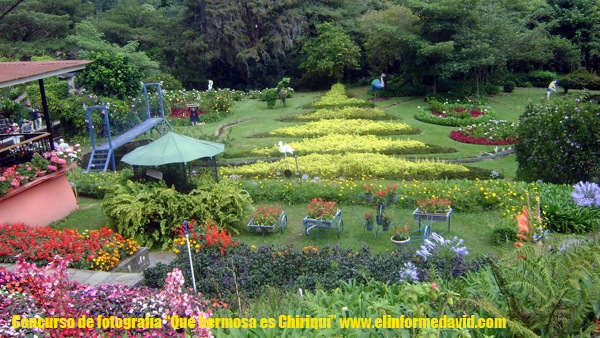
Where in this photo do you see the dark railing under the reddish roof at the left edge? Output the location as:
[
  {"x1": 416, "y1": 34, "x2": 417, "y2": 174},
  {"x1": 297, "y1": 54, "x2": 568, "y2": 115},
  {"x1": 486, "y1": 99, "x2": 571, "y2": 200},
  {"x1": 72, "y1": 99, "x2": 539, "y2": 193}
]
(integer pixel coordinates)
[{"x1": 0, "y1": 133, "x2": 52, "y2": 171}]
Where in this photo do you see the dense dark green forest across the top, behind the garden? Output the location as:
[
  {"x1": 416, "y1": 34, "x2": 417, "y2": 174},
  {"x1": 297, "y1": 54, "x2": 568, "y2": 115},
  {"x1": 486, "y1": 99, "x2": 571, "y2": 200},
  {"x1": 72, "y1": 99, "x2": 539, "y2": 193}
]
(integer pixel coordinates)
[{"x1": 0, "y1": 0, "x2": 600, "y2": 91}]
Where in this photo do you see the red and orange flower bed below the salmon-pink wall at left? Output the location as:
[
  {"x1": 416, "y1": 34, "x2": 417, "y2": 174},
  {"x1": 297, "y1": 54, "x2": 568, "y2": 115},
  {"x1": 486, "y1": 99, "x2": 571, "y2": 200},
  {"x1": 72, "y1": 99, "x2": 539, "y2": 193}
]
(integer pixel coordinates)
[{"x1": 0, "y1": 224, "x2": 139, "y2": 270}]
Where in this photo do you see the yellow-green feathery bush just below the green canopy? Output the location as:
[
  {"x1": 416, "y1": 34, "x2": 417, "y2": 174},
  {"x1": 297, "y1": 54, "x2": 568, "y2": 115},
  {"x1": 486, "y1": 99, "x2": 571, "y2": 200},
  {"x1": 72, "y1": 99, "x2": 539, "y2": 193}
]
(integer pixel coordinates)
[{"x1": 102, "y1": 180, "x2": 252, "y2": 249}]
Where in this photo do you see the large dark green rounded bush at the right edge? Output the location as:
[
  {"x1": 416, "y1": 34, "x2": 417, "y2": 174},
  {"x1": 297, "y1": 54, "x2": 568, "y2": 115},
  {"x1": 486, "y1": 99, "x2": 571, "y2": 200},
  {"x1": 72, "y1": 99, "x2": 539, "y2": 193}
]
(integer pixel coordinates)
[{"x1": 515, "y1": 97, "x2": 600, "y2": 184}]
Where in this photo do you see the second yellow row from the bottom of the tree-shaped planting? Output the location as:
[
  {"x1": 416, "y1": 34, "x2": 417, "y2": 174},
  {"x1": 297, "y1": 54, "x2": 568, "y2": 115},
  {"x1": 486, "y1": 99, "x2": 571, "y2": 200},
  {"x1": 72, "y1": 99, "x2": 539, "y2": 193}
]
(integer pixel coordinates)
[{"x1": 252, "y1": 134, "x2": 428, "y2": 156}]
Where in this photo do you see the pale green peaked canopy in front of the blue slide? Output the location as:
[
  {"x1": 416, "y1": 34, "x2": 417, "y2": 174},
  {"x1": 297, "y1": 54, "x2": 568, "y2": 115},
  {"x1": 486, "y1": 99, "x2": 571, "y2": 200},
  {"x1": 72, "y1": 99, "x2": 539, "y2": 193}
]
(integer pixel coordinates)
[{"x1": 121, "y1": 133, "x2": 225, "y2": 166}]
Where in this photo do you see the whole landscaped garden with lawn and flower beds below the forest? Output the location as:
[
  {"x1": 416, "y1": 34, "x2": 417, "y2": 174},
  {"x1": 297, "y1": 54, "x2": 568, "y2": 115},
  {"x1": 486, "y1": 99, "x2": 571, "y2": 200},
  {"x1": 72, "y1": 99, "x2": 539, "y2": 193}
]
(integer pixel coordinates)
[{"x1": 0, "y1": 84, "x2": 600, "y2": 337}]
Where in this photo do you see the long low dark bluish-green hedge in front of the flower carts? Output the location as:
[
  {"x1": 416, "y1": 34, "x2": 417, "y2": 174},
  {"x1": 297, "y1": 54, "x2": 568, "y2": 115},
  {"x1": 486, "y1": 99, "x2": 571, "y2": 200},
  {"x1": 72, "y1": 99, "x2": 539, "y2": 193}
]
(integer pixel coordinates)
[{"x1": 144, "y1": 243, "x2": 481, "y2": 303}]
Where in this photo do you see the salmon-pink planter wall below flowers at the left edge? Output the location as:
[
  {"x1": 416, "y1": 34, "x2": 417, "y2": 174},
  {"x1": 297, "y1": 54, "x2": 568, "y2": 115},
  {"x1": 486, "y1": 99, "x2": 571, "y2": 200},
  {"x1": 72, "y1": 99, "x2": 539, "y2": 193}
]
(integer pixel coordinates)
[{"x1": 0, "y1": 168, "x2": 79, "y2": 227}]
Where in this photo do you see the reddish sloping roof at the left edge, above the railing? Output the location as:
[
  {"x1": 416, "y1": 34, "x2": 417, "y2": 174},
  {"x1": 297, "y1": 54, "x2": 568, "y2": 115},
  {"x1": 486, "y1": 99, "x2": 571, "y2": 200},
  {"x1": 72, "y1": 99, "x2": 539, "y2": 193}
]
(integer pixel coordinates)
[{"x1": 0, "y1": 60, "x2": 92, "y2": 88}]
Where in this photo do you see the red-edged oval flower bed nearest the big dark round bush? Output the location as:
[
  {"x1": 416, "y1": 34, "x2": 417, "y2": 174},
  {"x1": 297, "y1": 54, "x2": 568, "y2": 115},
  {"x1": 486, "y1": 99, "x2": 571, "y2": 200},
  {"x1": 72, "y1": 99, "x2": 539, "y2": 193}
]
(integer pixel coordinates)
[{"x1": 450, "y1": 120, "x2": 518, "y2": 146}]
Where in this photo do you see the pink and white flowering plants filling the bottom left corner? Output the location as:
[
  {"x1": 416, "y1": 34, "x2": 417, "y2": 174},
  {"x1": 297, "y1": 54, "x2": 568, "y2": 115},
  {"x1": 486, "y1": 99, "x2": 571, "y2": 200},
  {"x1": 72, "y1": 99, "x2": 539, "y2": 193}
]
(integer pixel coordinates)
[{"x1": 0, "y1": 256, "x2": 220, "y2": 338}]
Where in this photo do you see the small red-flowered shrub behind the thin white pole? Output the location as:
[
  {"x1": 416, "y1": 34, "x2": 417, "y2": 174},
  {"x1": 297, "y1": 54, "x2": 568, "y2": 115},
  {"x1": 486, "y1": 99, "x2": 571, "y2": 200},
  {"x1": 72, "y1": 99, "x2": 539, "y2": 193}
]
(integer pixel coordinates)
[{"x1": 173, "y1": 220, "x2": 238, "y2": 255}]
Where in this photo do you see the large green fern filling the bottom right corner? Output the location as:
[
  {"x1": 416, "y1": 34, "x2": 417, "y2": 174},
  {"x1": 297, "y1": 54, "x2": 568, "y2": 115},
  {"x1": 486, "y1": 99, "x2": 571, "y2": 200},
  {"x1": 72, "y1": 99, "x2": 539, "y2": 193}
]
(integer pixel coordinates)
[{"x1": 467, "y1": 243, "x2": 600, "y2": 337}]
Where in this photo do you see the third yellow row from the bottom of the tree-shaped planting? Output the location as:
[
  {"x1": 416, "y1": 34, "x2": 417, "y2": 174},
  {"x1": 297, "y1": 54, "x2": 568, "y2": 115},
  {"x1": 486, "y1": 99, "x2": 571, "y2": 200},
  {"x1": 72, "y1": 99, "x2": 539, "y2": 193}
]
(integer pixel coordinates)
[{"x1": 269, "y1": 119, "x2": 418, "y2": 137}]
